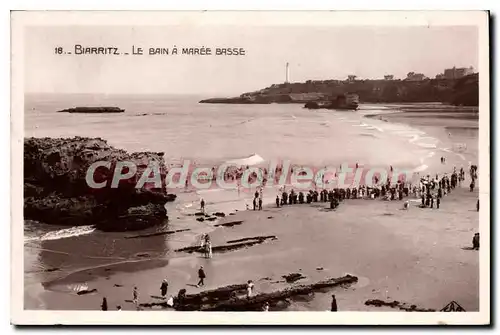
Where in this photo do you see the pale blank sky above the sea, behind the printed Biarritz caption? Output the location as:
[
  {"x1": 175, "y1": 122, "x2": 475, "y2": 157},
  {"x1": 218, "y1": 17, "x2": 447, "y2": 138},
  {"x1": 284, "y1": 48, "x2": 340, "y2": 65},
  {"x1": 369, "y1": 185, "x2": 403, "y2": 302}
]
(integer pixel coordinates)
[{"x1": 24, "y1": 25, "x2": 478, "y2": 96}]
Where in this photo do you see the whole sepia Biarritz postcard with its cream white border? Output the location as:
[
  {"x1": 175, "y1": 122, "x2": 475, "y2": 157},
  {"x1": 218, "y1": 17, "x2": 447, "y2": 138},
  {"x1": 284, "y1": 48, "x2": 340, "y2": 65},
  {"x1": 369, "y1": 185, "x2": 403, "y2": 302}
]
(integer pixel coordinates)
[{"x1": 11, "y1": 11, "x2": 490, "y2": 325}]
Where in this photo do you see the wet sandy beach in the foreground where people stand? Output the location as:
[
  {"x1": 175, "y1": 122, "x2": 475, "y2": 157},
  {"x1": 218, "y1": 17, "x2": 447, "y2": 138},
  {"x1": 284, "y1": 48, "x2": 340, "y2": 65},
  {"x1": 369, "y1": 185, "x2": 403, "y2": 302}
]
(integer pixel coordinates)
[{"x1": 25, "y1": 104, "x2": 479, "y2": 311}]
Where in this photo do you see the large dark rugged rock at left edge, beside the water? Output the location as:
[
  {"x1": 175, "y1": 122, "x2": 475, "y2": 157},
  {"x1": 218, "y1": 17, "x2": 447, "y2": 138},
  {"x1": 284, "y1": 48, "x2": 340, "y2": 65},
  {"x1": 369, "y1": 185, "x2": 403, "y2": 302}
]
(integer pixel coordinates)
[{"x1": 24, "y1": 137, "x2": 175, "y2": 231}]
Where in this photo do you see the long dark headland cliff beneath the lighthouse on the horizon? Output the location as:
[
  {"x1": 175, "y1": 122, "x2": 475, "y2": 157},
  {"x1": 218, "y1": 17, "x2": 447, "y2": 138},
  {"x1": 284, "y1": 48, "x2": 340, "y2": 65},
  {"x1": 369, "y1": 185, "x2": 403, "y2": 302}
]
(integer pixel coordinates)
[{"x1": 200, "y1": 73, "x2": 479, "y2": 106}]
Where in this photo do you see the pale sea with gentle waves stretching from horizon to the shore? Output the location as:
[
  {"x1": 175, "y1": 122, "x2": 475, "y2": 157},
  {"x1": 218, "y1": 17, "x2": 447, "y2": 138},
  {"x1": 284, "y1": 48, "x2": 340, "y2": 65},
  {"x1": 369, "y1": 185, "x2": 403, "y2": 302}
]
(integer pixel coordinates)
[{"x1": 24, "y1": 94, "x2": 468, "y2": 308}]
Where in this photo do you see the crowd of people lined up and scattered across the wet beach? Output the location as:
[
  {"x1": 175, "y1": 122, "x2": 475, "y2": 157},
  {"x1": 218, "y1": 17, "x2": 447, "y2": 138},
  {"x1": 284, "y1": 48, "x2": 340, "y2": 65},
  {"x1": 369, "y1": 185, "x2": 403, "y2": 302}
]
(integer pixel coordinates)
[{"x1": 96, "y1": 157, "x2": 479, "y2": 312}]
